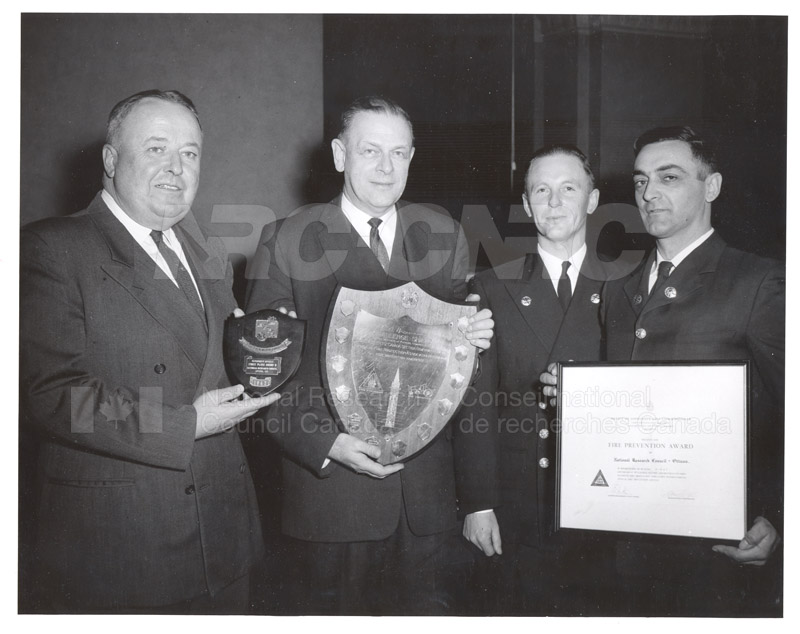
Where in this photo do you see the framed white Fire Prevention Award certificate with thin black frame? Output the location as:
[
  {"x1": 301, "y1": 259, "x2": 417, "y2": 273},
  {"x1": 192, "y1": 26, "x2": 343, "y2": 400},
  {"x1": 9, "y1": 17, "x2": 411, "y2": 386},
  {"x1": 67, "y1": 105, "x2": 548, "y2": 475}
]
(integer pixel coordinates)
[{"x1": 556, "y1": 361, "x2": 749, "y2": 541}]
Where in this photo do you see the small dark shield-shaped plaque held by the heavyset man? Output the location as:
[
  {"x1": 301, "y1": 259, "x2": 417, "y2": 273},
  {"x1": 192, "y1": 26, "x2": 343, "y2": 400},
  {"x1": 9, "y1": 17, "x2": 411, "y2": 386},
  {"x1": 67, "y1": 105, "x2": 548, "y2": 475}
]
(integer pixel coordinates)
[{"x1": 223, "y1": 309, "x2": 306, "y2": 396}]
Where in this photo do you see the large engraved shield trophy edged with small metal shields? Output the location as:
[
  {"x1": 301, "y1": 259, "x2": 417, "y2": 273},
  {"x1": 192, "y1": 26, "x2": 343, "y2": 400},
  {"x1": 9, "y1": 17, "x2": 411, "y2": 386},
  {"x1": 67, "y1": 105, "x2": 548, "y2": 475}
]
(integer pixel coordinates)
[{"x1": 323, "y1": 282, "x2": 477, "y2": 465}]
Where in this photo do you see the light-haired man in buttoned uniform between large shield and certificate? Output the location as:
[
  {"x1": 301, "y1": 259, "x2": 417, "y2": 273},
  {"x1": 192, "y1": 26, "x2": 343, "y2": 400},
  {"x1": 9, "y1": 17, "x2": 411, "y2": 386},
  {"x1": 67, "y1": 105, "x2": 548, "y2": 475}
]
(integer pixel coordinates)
[{"x1": 461, "y1": 145, "x2": 615, "y2": 615}]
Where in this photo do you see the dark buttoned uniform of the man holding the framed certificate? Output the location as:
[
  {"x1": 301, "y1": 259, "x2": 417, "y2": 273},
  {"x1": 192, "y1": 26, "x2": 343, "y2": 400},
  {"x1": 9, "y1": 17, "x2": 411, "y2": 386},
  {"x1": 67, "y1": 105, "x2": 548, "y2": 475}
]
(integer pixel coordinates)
[{"x1": 601, "y1": 233, "x2": 785, "y2": 615}]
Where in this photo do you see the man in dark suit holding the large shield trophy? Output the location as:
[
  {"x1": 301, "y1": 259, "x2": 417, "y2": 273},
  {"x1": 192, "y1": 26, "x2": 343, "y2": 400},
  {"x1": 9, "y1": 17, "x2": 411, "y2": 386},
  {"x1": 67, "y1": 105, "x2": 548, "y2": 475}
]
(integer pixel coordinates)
[{"x1": 247, "y1": 97, "x2": 493, "y2": 614}]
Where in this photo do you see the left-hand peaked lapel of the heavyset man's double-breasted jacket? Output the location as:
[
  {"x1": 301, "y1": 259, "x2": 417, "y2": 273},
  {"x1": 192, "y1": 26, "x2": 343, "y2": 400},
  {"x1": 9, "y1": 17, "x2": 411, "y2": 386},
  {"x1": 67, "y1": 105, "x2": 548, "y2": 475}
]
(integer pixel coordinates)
[{"x1": 88, "y1": 197, "x2": 207, "y2": 371}]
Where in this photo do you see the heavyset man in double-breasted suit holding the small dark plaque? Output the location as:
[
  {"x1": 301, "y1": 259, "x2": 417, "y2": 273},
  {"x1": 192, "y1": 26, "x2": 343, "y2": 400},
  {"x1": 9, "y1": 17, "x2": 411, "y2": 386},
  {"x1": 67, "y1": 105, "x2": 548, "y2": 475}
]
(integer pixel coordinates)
[{"x1": 20, "y1": 90, "x2": 277, "y2": 613}]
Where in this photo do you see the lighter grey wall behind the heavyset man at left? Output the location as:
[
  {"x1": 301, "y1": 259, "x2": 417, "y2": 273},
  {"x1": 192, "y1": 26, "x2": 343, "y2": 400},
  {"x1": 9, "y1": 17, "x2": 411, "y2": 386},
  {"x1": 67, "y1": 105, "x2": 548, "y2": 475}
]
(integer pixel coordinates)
[{"x1": 20, "y1": 14, "x2": 323, "y2": 264}]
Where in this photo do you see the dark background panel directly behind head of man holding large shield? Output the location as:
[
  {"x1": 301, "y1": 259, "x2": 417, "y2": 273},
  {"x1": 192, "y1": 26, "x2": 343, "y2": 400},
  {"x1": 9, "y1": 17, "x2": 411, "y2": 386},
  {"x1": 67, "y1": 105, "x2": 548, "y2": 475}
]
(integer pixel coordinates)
[{"x1": 324, "y1": 15, "x2": 512, "y2": 218}]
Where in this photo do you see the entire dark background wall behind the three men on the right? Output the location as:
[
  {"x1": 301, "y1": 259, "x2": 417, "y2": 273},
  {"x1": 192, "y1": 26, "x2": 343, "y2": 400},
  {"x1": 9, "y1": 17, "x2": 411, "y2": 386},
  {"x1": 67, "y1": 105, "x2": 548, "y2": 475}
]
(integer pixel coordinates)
[{"x1": 324, "y1": 15, "x2": 787, "y2": 266}]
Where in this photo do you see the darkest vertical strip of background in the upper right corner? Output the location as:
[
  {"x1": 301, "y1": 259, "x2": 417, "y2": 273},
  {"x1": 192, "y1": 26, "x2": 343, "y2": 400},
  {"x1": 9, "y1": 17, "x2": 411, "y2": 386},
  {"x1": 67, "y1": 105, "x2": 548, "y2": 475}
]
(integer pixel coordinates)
[{"x1": 703, "y1": 16, "x2": 788, "y2": 259}]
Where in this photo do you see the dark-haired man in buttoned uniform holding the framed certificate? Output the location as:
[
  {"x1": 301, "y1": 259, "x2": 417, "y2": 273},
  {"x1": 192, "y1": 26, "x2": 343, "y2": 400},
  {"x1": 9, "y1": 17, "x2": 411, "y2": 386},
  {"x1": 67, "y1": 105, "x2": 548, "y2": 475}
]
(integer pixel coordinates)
[{"x1": 542, "y1": 127, "x2": 785, "y2": 616}]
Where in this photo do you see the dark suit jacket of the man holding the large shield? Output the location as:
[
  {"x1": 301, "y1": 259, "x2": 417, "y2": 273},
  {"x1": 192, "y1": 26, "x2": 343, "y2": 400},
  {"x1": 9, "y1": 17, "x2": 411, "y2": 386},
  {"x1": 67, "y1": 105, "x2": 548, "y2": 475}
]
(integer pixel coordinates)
[{"x1": 247, "y1": 200, "x2": 491, "y2": 542}]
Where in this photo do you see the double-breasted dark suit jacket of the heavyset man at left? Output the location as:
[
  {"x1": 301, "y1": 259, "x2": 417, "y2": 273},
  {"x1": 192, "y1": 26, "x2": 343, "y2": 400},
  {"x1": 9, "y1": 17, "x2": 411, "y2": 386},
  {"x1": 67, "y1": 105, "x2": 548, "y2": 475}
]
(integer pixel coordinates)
[{"x1": 20, "y1": 195, "x2": 263, "y2": 608}]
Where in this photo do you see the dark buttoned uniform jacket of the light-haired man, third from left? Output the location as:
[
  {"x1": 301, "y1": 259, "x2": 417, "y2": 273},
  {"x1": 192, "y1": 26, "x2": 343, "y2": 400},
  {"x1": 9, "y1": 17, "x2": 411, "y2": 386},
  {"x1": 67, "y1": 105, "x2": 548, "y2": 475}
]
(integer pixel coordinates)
[{"x1": 462, "y1": 249, "x2": 614, "y2": 547}]
